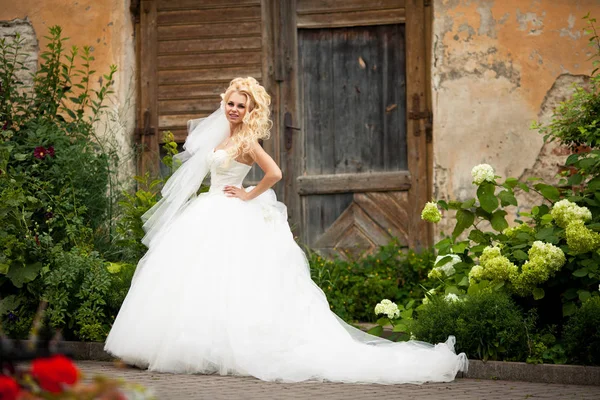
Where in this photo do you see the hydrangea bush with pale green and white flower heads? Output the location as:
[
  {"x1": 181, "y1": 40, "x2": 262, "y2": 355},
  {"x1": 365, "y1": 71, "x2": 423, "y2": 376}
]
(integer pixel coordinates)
[{"x1": 424, "y1": 161, "x2": 600, "y2": 323}]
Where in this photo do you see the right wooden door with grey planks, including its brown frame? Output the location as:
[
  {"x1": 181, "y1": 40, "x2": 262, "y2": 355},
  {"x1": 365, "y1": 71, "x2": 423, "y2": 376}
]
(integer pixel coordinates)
[{"x1": 284, "y1": 0, "x2": 431, "y2": 256}]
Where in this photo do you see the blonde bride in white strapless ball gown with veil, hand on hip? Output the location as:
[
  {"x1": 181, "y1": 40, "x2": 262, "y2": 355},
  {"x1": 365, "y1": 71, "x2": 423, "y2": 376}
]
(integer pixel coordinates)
[{"x1": 105, "y1": 78, "x2": 467, "y2": 384}]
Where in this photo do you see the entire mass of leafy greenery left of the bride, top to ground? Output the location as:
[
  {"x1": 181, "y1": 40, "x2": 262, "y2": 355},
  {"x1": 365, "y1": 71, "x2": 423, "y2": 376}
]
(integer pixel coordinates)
[{"x1": 0, "y1": 26, "x2": 129, "y2": 340}]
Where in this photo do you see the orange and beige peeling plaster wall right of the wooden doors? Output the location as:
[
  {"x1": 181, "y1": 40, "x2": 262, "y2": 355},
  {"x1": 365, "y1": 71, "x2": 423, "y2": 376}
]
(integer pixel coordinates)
[{"x1": 432, "y1": 0, "x2": 600, "y2": 233}]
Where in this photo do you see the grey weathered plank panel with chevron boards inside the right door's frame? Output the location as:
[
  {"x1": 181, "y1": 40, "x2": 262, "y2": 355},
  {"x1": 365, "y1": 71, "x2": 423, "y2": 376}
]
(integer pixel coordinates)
[{"x1": 298, "y1": 24, "x2": 410, "y2": 255}]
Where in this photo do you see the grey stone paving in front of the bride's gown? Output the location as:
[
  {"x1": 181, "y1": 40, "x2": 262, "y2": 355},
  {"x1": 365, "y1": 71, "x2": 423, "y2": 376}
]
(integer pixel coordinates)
[{"x1": 77, "y1": 361, "x2": 600, "y2": 400}]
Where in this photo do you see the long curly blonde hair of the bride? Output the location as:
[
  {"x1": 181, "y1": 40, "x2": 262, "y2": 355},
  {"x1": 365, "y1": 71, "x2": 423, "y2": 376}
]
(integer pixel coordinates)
[{"x1": 221, "y1": 77, "x2": 273, "y2": 159}]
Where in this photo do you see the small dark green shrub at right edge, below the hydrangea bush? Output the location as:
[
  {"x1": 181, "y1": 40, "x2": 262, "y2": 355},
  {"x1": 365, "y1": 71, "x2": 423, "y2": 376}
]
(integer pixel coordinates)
[{"x1": 562, "y1": 296, "x2": 600, "y2": 365}]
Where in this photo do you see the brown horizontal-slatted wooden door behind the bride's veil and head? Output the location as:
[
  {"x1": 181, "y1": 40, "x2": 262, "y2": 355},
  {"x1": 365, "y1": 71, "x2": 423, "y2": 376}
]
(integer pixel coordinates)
[{"x1": 137, "y1": 0, "x2": 263, "y2": 180}]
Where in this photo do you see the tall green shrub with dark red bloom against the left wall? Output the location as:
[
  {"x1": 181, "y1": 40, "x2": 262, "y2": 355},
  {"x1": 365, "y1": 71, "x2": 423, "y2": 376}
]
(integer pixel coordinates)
[{"x1": 0, "y1": 26, "x2": 117, "y2": 295}]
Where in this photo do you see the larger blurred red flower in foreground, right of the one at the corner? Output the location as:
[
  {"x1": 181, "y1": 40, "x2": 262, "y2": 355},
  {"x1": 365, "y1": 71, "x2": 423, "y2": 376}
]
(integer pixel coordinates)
[{"x1": 31, "y1": 355, "x2": 79, "y2": 393}]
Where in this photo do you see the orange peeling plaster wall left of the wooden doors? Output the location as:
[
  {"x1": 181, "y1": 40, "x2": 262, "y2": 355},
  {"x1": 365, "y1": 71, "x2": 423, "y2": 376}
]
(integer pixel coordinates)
[{"x1": 0, "y1": 0, "x2": 135, "y2": 175}]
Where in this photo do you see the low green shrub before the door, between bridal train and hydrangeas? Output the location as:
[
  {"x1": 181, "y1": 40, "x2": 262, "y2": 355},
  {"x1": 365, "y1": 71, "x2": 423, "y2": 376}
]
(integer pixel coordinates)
[{"x1": 309, "y1": 239, "x2": 432, "y2": 322}]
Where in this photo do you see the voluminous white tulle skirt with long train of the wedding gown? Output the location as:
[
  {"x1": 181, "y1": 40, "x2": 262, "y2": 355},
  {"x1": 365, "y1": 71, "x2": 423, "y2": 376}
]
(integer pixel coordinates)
[{"x1": 105, "y1": 191, "x2": 467, "y2": 384}]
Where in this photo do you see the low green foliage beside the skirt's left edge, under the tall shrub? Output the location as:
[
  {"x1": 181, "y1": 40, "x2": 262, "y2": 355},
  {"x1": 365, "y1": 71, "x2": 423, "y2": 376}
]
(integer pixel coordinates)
[{"x1": 0, "y1": 247, "x2": 135, "y2": 341}]
